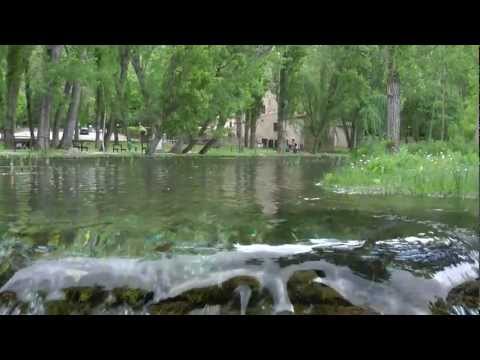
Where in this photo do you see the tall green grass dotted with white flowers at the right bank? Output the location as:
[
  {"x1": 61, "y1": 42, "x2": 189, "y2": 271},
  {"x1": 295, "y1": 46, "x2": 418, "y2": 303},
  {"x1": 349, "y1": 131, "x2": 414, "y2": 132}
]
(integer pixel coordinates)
[{"x1": 322, "y1": 142, "x2": 479, "y2": 198}]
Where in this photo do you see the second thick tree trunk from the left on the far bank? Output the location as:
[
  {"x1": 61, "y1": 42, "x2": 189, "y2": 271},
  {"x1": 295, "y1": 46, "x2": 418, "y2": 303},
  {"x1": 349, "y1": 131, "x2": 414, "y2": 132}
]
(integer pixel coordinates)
[{"x1": 36, "y1": 45, "x2": 63, "y2": 150}]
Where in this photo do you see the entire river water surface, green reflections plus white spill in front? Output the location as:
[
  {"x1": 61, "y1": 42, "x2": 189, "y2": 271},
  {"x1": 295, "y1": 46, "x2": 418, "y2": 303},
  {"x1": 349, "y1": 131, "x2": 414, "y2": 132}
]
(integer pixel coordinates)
[{"x1": 0, "y1": 157, "x2": 478, "y2": 314}]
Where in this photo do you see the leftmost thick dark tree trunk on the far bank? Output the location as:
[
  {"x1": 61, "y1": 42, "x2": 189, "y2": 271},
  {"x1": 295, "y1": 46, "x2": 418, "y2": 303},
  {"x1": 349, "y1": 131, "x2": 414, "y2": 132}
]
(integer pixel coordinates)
[{"x1": 4, "y1": 45, "x2": 24, "y2": 150}]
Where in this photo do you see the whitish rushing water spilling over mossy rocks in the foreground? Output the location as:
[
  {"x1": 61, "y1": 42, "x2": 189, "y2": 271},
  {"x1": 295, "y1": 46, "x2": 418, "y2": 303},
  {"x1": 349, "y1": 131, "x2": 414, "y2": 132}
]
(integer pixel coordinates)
[{"x1": 0, "y1": 239, "x2": 478, "y2": 314}]
